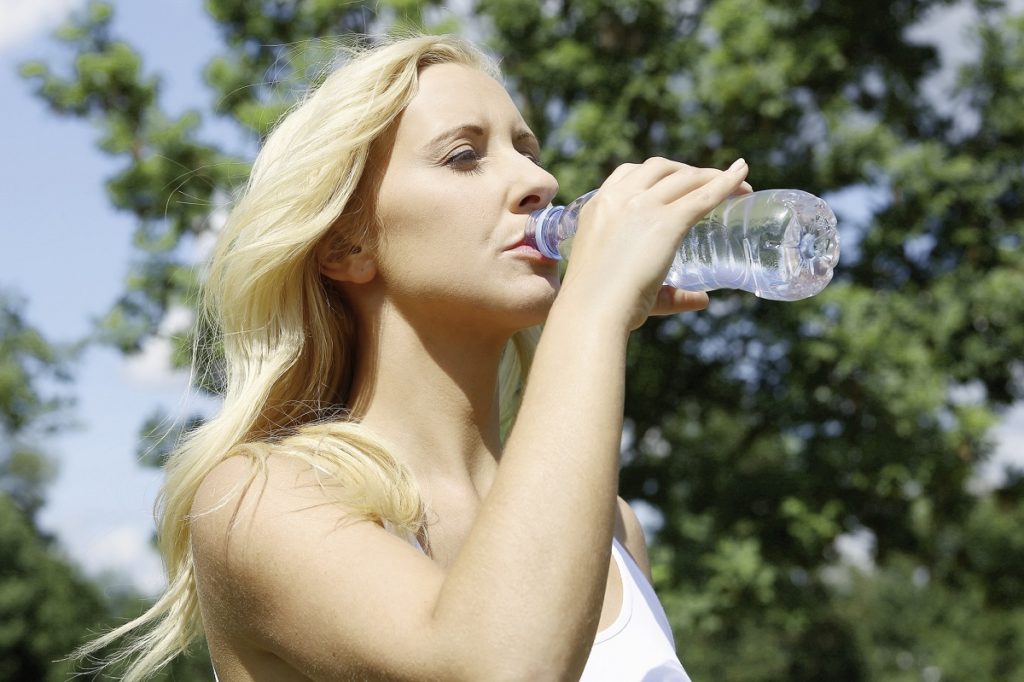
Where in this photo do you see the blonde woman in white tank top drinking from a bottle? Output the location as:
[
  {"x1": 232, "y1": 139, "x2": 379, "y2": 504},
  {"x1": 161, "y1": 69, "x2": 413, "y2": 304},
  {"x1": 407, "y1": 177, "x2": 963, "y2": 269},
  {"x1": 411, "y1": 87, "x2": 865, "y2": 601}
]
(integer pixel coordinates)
[{"x1": 81, "y1": 37, "x2": 750, "y2": 682}]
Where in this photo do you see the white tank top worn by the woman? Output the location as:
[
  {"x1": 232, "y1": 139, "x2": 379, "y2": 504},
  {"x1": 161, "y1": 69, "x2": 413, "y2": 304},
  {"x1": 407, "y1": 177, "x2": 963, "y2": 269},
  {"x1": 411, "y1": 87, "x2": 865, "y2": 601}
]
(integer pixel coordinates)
[{"x1": 580, "y1": 538, "x2": 690, "y2": 682}]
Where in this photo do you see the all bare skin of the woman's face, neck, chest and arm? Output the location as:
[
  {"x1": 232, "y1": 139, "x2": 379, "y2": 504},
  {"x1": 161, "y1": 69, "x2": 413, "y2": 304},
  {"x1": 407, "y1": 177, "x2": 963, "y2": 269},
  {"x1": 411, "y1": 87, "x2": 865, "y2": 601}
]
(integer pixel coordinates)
[{"x1": 193, "y1": 65, "x2": 750, "y2": 682}]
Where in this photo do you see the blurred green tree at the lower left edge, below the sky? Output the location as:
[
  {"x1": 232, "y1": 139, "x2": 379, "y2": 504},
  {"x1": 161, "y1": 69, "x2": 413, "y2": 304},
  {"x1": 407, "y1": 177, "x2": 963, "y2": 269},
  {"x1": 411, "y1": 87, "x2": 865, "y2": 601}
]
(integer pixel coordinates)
[{"x1": 0, "y1": 290, "x2": 106, "y2": 681}]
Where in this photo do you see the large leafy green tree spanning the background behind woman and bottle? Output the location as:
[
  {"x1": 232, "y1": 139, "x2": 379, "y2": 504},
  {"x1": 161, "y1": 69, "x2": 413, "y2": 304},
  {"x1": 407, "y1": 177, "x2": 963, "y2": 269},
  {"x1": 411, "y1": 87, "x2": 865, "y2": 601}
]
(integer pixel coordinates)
[{"x1": 26, "y1": 0, "x2": 1024, "y2": 681}]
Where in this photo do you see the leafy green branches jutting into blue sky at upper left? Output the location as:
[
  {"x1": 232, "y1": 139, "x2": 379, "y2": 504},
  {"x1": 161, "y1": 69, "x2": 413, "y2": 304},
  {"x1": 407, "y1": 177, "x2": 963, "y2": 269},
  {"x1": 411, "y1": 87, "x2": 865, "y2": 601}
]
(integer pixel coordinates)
[{"x1": 22, "y1": 2, "x2": 248, "y2": 360}]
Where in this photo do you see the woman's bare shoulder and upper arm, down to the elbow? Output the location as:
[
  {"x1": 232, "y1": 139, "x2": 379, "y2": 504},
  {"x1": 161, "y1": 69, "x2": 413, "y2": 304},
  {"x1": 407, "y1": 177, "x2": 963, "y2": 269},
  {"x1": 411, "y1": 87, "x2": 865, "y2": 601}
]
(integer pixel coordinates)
[{"x1": 191, "y1": 454, "x2": 443, "y2": 679}]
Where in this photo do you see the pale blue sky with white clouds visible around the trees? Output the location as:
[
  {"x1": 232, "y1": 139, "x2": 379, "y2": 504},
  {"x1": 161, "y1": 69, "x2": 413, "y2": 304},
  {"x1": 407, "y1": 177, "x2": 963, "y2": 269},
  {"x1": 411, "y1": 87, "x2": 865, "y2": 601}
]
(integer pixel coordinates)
[{"x1": 0, "y1": 0, "x2": 1024, "y2": 592}]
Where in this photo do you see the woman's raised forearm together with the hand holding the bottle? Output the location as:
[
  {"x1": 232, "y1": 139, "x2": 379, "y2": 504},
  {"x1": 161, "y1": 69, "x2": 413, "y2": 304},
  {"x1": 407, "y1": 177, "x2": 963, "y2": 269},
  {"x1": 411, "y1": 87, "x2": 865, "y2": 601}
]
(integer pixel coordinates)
[{"x1": 434, "y1": 159, "x2": 745, "y2": 679}]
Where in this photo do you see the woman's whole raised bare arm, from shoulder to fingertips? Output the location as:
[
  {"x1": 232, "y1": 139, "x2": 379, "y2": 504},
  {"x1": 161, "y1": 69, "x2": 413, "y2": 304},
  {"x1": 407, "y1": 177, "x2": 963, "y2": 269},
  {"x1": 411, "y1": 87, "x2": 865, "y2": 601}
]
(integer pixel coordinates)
[{"x1": 194, "y1": 160, "x2": 745, "y2": 682}]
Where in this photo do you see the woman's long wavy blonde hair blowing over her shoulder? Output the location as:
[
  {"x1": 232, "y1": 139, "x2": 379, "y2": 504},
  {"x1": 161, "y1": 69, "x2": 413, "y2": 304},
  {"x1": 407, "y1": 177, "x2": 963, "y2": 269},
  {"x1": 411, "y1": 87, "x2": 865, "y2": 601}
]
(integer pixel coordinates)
[{"x1": 77, "y1": 36, "x2": 540, "y2": 682}]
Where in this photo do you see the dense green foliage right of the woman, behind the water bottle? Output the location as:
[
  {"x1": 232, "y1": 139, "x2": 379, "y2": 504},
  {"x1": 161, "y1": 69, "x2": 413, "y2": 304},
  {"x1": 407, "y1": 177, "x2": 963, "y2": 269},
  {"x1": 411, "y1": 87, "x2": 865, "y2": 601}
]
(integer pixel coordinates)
[{"x1": 476, "y1": 0, "x2": 1024, "y2": 680}]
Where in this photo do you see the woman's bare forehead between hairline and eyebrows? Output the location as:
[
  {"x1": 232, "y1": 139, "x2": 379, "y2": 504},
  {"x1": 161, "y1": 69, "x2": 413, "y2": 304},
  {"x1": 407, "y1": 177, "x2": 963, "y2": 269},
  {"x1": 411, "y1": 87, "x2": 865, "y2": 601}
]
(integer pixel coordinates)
[{"x1": 387, "y1": 63, "x2": 525, "y2": 144}]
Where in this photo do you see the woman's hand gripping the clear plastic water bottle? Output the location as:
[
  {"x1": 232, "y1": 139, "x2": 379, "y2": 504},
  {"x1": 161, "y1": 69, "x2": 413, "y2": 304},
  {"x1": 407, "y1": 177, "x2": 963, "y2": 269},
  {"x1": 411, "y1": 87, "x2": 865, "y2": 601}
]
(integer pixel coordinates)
[{"x1": 559, "y1": 158, "x2": 752, "y2": 330}]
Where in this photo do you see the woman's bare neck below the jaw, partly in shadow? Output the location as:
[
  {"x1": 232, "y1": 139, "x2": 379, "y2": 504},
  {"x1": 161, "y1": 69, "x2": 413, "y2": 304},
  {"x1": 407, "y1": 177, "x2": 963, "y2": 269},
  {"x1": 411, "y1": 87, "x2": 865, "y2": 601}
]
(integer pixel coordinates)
[{"x1": 349, "y1": 306, "x2": 508, "y2": 496}]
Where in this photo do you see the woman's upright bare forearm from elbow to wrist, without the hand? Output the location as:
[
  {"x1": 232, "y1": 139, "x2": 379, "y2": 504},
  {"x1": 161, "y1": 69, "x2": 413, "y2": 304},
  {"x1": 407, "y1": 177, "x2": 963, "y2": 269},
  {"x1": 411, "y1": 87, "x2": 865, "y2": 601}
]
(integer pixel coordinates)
[{"x1": 435, "y1": 292, "x2": 628, "y2": 674}]
